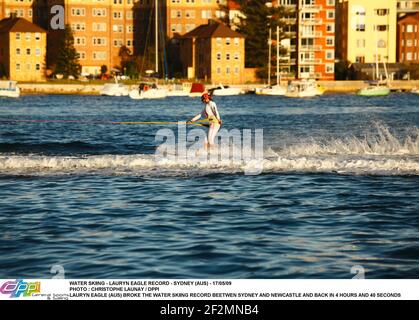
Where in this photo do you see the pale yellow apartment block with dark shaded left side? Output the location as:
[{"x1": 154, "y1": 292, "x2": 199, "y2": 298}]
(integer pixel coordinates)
[{"x1": 336, "y1": 0, "x2": 397, "y2": 63}]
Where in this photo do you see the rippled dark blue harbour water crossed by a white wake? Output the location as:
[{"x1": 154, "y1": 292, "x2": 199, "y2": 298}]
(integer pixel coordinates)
[{"x1": 0, "y1": 94, "x2": 419, "y2": 279}]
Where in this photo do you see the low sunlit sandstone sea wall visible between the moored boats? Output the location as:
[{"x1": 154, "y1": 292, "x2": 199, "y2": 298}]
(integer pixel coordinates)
[{"x1": 12, "y1": 80, "x2": 419, "y2": 95}]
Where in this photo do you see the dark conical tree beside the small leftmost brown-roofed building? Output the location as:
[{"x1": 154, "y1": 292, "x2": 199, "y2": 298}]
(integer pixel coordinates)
[{"x1": 55, "y1": 25, "x2": 81, "y2": 77}]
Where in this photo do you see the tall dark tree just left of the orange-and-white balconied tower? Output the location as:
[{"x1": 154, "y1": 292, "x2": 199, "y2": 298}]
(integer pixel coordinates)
[{"x1": 236, "y1": 0, "x2": 287, "y2": 68}]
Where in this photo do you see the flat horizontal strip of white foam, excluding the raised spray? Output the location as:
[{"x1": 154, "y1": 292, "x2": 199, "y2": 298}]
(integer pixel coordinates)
[{"x1": 0, "y1": 154, "x2": 419, "y2": 175}]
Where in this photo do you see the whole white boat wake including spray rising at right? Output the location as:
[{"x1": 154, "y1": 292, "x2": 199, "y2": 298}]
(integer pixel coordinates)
[{"x1": 0, "y1": 127, "x2": 419, "y2": 176}]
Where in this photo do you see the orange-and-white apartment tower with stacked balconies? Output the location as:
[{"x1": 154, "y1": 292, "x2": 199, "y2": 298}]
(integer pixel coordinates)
[{"x1": 273, "y1": 0, "x2": 335, "y2": 80}]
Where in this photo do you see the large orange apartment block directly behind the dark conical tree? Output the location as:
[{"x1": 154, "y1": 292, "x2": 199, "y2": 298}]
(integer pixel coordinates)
[{"x1": 39, "y1": 0, "x2": 136, "y2": 75}]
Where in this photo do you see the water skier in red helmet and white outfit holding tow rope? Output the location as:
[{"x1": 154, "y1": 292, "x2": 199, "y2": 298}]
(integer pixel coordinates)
[{"x1": 188, "y1": 92, "x2": 222, "y2": 149}]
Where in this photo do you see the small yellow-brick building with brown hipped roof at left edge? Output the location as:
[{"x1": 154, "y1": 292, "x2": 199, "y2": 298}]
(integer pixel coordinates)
[{"x1": 0, "y1": 18, "x2": 47, "y2": 81}]
